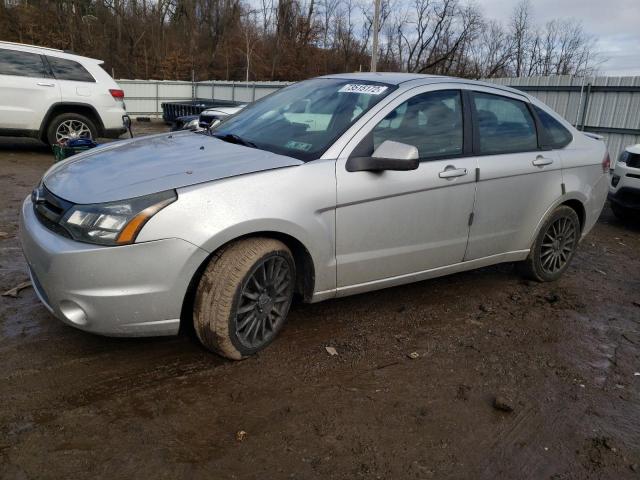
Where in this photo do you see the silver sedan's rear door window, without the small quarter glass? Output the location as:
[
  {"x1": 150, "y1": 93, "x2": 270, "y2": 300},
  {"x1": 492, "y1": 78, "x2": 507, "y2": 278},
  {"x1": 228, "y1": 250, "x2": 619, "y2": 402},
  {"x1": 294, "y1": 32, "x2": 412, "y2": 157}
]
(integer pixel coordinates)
[{"x1": 473, "y1": 92, "x2": 538, "y2": 154}]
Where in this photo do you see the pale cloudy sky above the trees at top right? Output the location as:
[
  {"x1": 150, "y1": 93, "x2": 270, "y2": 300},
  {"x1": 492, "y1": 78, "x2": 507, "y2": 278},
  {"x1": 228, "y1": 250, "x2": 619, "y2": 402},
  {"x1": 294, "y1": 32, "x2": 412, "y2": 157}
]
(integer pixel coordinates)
[{"x1": 475, "y1": 0, "x2": 640, "y2": 76}]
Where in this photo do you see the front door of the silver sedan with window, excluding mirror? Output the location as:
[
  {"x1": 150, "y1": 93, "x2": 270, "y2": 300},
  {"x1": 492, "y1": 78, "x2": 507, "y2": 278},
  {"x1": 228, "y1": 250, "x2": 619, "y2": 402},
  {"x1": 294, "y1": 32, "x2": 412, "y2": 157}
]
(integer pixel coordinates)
[{"x1": 336, "y1": 87, "x2": 476, "y2": 291}]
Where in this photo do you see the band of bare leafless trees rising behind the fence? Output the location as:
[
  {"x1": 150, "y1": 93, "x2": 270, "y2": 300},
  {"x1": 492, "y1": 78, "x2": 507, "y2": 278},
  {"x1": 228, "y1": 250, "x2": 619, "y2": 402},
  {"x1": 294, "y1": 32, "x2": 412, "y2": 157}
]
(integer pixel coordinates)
[{"x1": 0, "y1": 0, "x2": 599, "y2": 80}]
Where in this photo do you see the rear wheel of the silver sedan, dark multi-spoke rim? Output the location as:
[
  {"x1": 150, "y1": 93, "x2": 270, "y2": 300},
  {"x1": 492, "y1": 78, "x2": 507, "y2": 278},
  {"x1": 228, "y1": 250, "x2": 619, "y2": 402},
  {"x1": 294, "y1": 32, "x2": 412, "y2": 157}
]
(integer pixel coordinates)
[{"x1": 519, "y1": 206, "x2": 580, "y2": 282}]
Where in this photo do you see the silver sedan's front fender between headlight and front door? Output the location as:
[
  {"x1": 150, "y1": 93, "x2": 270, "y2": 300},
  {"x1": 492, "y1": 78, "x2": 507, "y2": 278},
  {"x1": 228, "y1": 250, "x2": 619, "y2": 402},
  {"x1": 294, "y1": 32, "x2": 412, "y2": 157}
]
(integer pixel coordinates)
[{"x1": 138, "y1": 160, "x2": 336, "y2": 298}]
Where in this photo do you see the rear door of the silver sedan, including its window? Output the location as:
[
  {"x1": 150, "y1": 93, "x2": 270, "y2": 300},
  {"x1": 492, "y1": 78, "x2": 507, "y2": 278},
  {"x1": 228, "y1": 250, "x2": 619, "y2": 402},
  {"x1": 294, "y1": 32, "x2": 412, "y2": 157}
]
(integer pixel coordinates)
[{"x1": 465, "y1": 89, "x2": 562, "y2": 260}]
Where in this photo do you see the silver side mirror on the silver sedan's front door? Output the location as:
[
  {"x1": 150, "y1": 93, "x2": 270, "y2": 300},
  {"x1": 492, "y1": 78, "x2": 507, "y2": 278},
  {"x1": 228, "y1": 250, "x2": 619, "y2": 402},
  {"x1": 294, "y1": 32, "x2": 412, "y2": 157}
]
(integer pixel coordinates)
[{"x1": 346, "y1": 140, "x2": 420, "y2": 172}]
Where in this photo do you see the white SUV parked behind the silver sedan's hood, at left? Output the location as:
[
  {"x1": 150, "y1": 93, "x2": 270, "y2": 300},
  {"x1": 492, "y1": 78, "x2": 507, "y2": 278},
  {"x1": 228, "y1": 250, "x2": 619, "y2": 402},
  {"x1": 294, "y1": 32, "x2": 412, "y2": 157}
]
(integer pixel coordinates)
[{"x1": 0, "y1": 42, "x2": 128, "y2": 145}]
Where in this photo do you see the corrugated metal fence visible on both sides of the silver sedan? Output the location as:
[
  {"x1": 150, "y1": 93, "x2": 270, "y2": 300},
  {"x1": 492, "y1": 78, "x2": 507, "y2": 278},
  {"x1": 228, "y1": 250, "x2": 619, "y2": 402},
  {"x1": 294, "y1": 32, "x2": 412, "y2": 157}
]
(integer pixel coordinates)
[{"x1": 118, "y1": 76, "x2": 640, "y2": 159}]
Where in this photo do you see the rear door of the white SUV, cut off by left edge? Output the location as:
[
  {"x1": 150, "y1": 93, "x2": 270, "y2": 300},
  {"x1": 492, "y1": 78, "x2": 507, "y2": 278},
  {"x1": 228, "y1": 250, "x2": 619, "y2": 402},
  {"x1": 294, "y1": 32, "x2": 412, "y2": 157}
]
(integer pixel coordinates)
[{"x1": 0, "y1": 48, "x2": 60, "y2": 133}]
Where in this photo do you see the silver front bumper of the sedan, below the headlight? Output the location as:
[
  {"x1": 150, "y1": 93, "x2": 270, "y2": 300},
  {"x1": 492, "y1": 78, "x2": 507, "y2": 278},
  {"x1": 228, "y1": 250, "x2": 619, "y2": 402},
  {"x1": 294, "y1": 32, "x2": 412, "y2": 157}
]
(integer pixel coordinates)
[{"x1": 20, "y1": 198, "x2": 208, "y2": 336}]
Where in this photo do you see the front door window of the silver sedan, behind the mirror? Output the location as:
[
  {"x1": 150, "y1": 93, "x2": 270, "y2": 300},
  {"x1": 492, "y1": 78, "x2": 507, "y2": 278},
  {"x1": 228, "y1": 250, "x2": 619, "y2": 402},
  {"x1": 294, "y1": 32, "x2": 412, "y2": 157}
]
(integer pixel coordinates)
[{"x1": 352, "y1": 90, "x2": 463, "y2": 160}]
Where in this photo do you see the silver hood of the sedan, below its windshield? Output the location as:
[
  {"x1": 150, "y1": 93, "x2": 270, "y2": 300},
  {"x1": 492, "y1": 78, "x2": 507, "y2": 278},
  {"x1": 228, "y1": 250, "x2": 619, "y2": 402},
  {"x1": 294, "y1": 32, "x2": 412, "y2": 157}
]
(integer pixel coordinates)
[{"x1": 43, "y1": 132, "x2": 303, "y2": 203}]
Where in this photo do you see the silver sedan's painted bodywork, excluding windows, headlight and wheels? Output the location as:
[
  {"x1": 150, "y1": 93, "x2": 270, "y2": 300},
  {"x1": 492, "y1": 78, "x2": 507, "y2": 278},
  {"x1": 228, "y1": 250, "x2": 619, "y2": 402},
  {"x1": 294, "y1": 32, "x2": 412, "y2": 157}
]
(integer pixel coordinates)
[{"x1": 22, "y1": 73, "x2": 608, "y2": 335}]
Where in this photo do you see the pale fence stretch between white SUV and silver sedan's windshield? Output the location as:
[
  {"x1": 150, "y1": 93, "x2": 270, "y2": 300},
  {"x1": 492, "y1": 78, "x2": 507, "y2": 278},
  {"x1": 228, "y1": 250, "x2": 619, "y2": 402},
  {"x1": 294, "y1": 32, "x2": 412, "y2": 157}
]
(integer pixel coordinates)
[{"x1": 116, "y1": 80, "x2": 289, "y2": 116}]
